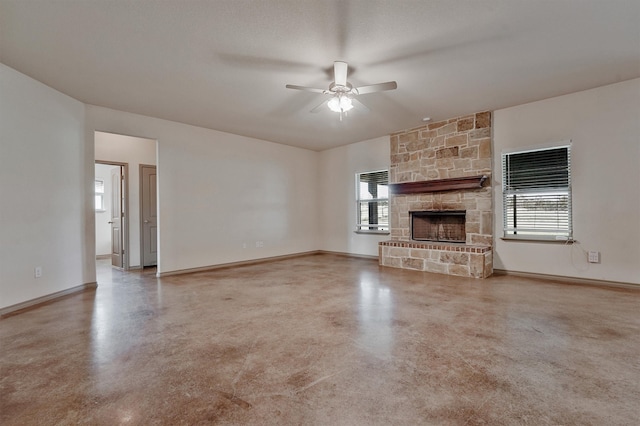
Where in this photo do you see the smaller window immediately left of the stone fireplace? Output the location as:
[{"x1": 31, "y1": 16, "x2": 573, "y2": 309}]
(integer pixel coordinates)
[{"x1": 356, "y1": 170, "x2": 389, "y2": 233}]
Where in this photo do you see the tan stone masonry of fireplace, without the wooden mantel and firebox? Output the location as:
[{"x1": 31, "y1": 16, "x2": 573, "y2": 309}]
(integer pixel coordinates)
[{"x1": 380, "y1": 111, "x2": 493, "y2": 278}]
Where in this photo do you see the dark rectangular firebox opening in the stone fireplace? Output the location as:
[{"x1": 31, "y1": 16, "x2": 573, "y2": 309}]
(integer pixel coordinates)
[{"x1": 409, "y1": 210, "x2": 467, "y2": 243}]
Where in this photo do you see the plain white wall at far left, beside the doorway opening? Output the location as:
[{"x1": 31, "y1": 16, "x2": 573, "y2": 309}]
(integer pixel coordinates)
[{"x1": 0, "y1": 64, "x2": 95, "y2": 308}]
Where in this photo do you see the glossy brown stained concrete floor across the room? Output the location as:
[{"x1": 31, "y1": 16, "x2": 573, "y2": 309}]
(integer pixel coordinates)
[{"x1": 0, "y1": 254, "x2": 640, "y2": 426}]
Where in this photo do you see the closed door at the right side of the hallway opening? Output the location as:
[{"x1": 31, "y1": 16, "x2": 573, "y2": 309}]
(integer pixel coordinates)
[{"x1": 140, "y1": 165, "x2": 158, "y2": 267}]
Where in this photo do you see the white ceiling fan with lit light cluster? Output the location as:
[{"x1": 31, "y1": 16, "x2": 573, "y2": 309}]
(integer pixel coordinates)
[{"x1": 286, "y1": 61, "x2": 398, "y2": 121}]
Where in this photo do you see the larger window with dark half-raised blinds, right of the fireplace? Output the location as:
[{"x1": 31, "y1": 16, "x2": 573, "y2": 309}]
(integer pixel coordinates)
[{"x1": 502, "y1": 145, "x2": 573, "y2": 240}]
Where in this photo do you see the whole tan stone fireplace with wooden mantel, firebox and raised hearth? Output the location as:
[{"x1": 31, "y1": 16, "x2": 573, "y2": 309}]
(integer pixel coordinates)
[{"x1": 379, "y1": 112, "x2": 493, "y2": 278}]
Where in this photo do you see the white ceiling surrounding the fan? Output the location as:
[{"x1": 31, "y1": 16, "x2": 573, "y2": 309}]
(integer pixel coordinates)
[{"x1": 0, "y1": 0, "x2": 640, "y2": 150}]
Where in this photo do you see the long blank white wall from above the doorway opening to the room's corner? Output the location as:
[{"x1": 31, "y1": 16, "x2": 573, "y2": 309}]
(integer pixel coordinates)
[{"x1": 86, "y1": 105, "x2": 319, "y2": 273}]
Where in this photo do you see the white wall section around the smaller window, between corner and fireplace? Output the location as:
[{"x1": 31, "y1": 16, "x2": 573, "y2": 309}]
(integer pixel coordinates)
[{"x1": 319, "y1": 136, "x2": 390, "y2": 256}]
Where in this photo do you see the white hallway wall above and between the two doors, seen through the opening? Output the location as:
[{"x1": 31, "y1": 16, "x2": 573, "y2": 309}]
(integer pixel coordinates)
[{"x1": 95, "y1": 132, "x2": 156, "y2": 268}]
